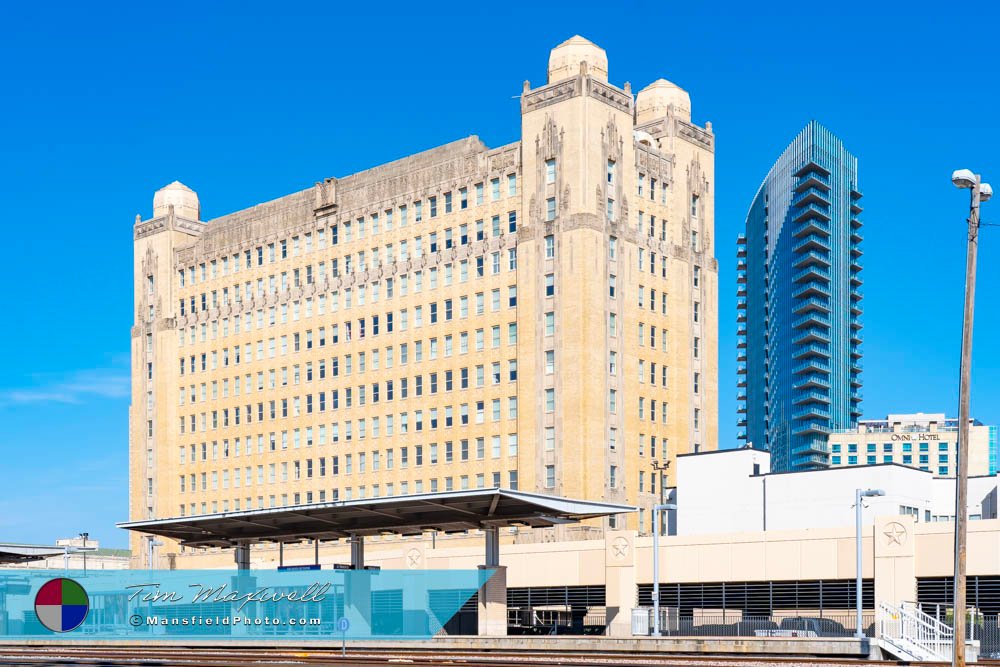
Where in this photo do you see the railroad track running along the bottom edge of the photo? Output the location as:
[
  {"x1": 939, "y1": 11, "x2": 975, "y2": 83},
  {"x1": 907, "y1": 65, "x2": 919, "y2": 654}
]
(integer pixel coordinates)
[{"x1": 0, "y1": 644, "x2": 976, "y2": 667}]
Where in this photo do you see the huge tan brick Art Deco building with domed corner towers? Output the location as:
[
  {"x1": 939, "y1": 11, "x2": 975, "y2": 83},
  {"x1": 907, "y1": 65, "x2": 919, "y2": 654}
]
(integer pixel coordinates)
[{"x1": 130, "y1": 37, "x2": 718, "y2": 554}]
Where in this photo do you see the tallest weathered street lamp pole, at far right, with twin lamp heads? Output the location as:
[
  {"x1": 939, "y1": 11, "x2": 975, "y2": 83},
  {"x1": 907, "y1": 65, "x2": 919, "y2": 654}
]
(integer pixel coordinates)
[{"x1": 951, "y1": 169, "x2": 993, "y2": 667}]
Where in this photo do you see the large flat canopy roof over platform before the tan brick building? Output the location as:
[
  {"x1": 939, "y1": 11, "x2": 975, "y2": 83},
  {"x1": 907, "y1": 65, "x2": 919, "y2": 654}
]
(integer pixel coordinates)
[{"x1": 118, "y1": 488, "x2": 635, "y2": 547}]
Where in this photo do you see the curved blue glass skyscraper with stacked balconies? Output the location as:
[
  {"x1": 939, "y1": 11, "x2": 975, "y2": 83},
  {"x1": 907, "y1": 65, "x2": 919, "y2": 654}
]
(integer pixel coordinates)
[{"x1": 737, "y1": 121, "x2": 861, "y2": 471}]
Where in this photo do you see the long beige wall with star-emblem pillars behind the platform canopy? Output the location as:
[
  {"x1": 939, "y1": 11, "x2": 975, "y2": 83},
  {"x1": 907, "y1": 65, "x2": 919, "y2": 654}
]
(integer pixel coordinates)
[{"x1": 166, "y1": 516, "x2": 1000, "y2": 605}]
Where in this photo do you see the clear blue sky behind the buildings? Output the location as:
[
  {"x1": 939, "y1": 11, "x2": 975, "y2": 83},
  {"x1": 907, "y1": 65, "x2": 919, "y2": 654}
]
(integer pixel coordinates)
[{"x1": 0, "y1": 2, "x2": 1000, "y2": 546}]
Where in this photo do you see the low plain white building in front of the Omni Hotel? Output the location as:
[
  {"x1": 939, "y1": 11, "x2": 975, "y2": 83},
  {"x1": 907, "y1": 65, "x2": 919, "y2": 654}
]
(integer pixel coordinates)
[{"x1": 671, "y1": 448, "x2": 997, "y2": 535}]
